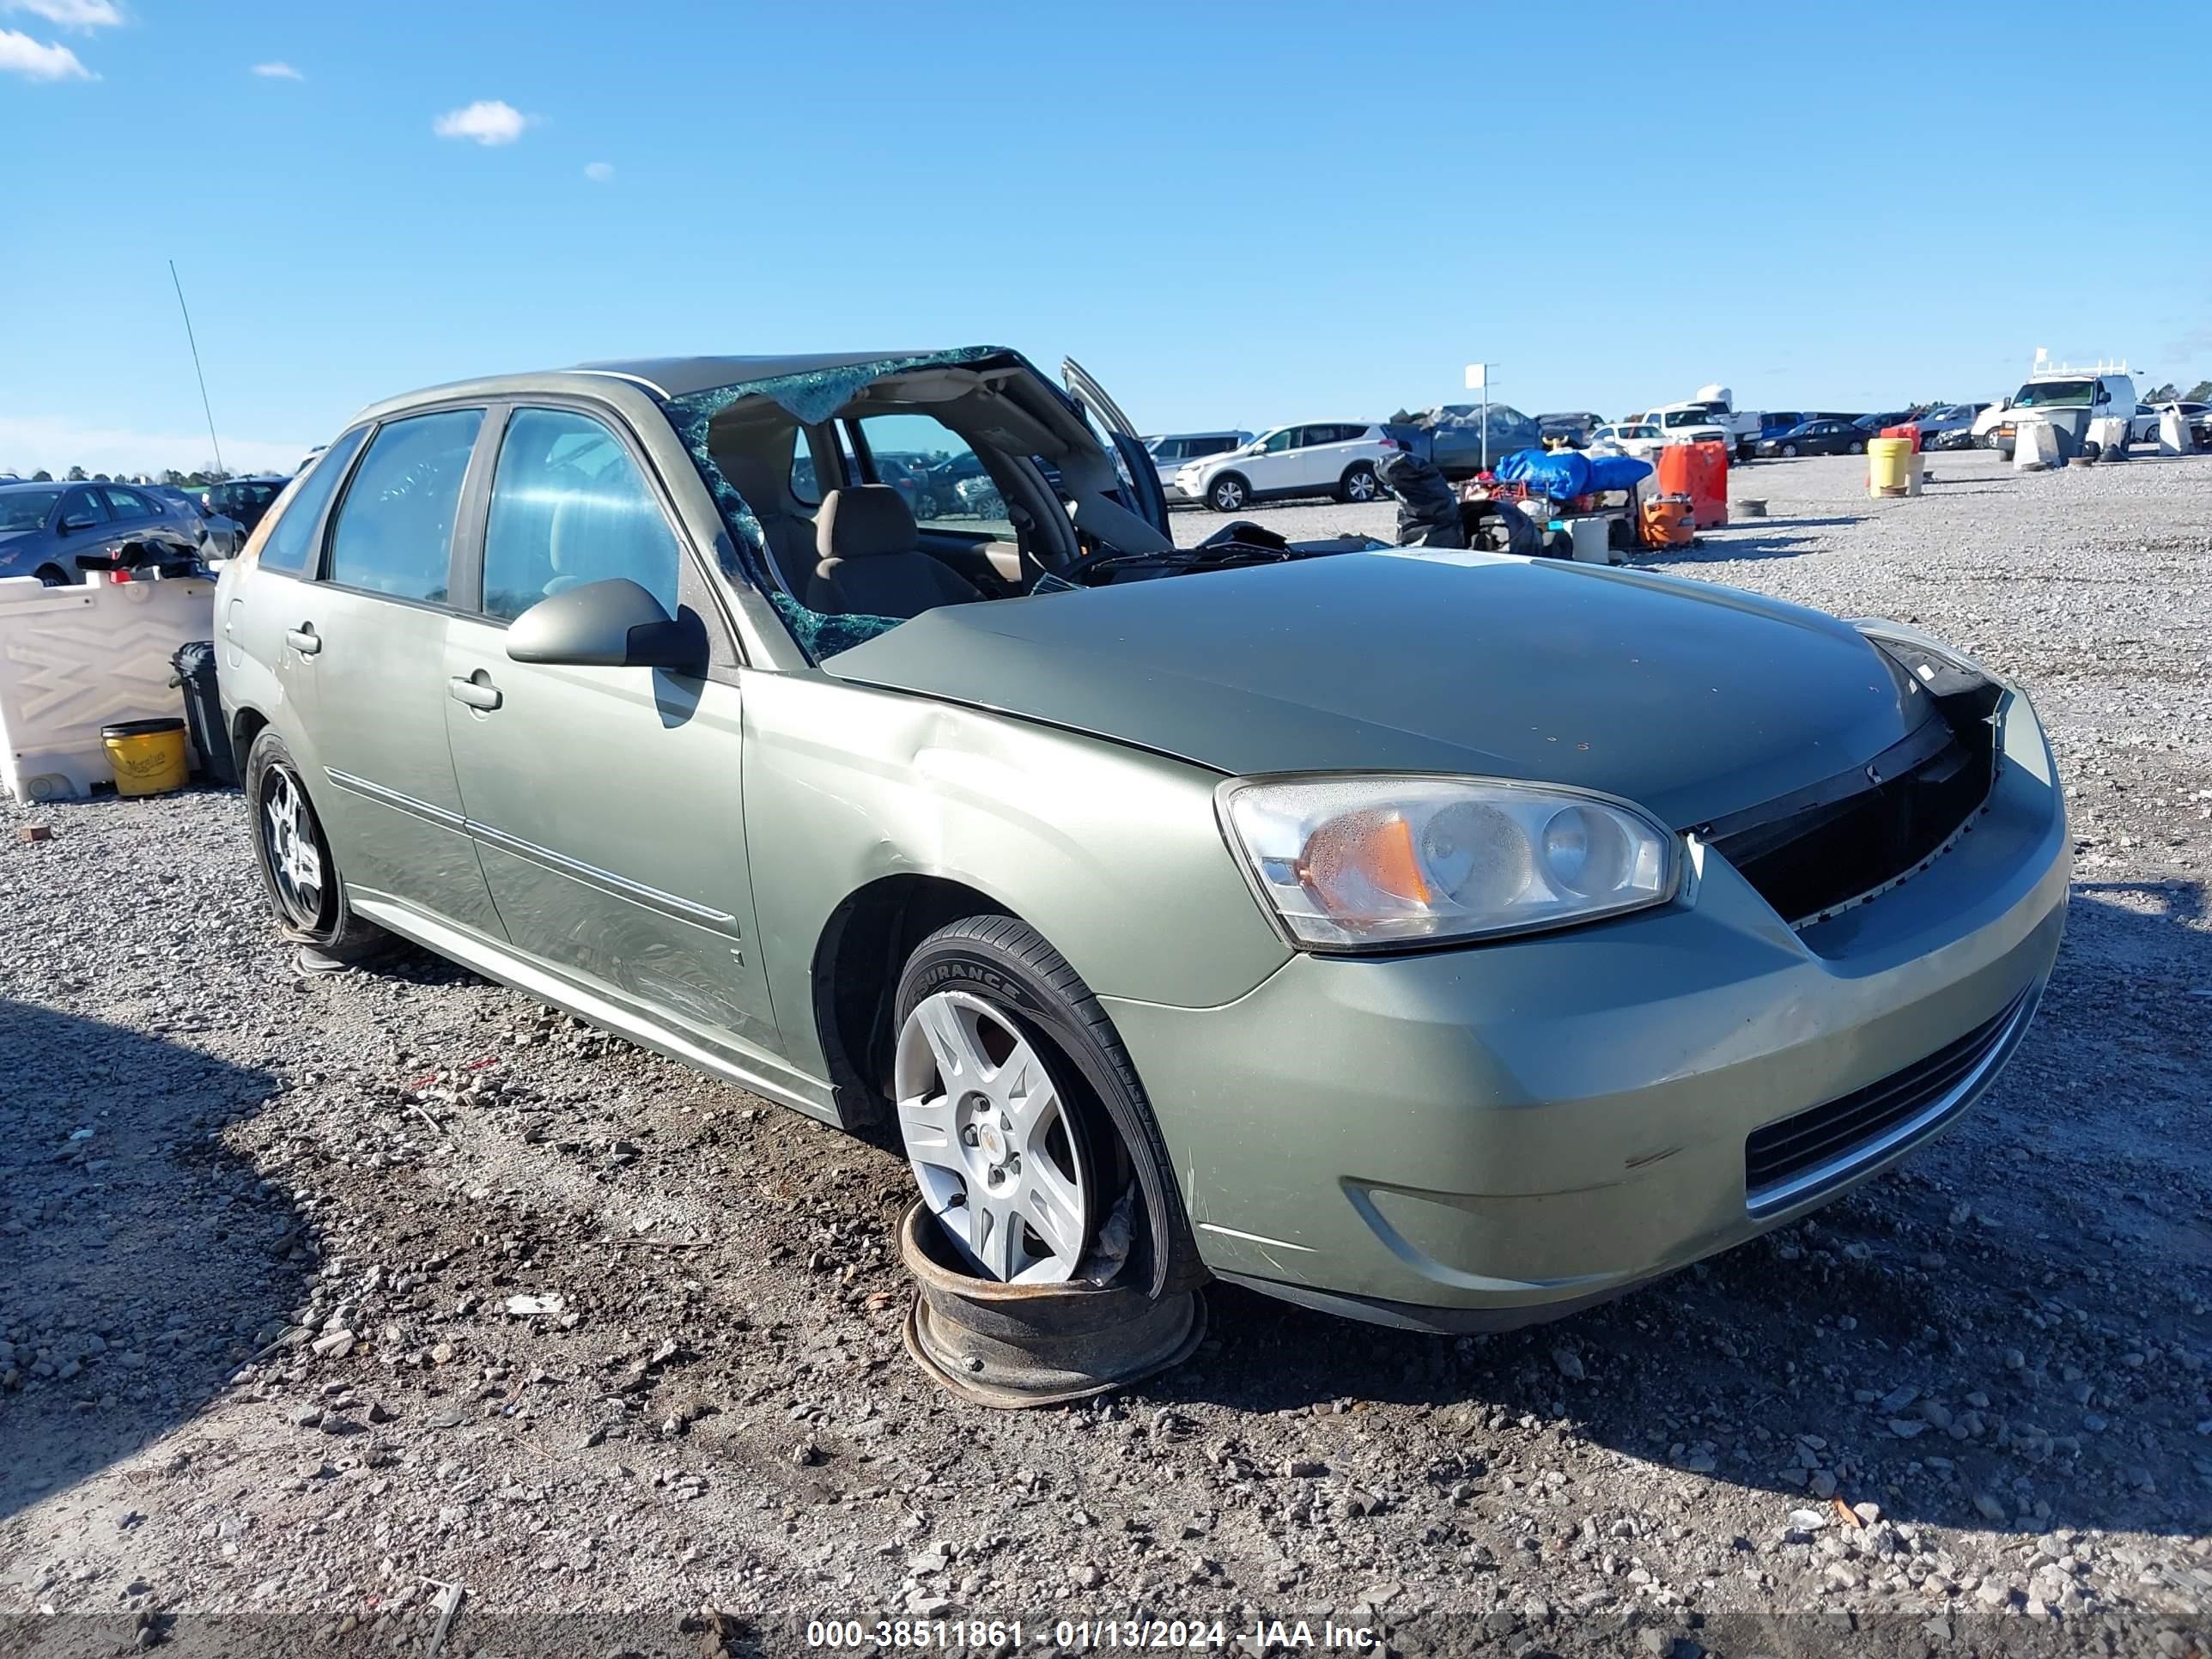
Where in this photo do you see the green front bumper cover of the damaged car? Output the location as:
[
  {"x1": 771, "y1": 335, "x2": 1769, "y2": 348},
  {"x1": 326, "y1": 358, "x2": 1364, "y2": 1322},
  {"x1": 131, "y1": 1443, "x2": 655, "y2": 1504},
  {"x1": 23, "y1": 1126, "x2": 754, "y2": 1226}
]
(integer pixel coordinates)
[{"x1": 1109, "y1": 696, "x2": 2070, "y2": 1329}]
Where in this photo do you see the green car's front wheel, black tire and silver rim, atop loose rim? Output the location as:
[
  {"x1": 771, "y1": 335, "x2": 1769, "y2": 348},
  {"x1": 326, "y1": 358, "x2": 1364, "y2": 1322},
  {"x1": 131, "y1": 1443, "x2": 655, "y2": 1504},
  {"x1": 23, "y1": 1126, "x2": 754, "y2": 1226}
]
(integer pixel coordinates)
[{"x1": 891, "y1": 915, "x2": 1203, "y2": 1297}]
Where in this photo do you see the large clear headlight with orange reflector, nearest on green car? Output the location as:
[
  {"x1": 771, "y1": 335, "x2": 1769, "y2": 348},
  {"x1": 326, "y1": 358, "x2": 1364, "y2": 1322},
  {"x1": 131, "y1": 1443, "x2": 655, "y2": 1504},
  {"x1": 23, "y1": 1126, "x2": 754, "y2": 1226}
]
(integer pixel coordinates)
[{"x1": 1217, "y1": 775, "x2": 1679, "y2": 949}]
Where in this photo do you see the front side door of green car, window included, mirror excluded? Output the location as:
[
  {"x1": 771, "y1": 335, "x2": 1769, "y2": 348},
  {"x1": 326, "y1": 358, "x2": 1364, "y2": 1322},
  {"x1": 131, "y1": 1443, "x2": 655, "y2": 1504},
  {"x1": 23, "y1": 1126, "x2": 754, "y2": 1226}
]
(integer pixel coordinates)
[{"x1": 438, "y1": 403, "x2": 779, "y2": 1066}]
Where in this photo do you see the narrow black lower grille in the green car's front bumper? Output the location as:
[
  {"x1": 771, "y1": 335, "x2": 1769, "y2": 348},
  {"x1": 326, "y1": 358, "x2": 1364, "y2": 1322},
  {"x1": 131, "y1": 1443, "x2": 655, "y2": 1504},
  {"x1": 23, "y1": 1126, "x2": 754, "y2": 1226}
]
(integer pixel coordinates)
[{"x1": 1743, "y1": 991, "x2": 2033, "y2": 1214}]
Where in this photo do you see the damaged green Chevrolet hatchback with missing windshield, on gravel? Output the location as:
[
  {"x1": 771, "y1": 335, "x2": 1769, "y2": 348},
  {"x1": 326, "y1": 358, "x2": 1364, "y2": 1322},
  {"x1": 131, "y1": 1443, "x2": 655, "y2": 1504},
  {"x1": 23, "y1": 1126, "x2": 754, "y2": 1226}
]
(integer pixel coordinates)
[{"x1": 216, "y1": 347, "x2": 2069, "y2": 1329}]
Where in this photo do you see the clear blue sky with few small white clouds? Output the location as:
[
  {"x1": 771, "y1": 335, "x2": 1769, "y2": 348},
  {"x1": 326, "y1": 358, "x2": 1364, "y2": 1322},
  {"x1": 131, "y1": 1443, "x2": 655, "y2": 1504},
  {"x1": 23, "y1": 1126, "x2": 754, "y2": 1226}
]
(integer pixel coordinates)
[{"x1": 0, "y1": 0, "x2": 2212, "y2": 471}]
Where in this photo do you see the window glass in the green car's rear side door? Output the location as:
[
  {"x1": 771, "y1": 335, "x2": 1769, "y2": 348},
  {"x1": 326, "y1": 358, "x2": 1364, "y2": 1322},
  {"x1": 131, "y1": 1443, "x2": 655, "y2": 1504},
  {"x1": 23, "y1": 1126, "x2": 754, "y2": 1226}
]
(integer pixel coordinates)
[{"x1": 323, "y1": 410, "x2": 484, "y2": 604}]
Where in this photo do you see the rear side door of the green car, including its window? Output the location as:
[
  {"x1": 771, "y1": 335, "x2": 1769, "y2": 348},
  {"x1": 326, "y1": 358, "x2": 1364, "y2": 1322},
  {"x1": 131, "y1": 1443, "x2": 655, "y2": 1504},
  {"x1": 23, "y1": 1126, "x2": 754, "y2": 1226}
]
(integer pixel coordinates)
[{"x1": 276, "y1": 407, "x2": 500, "y2": 938}]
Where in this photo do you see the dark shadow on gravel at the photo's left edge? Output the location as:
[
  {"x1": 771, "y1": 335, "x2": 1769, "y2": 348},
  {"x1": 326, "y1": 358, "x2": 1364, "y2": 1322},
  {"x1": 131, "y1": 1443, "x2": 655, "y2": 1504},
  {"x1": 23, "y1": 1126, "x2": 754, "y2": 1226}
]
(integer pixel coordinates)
[{"x1": 0, "y1": 1000, "x2": 314, "y2": 1520}]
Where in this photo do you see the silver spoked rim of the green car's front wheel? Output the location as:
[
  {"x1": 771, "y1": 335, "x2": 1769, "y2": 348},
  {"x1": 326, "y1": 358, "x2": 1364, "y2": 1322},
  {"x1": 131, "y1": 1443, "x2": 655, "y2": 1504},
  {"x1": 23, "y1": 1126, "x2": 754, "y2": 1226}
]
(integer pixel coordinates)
[{"x1": 891, "y1": 991, "x2": 1093, "y2": 1285}]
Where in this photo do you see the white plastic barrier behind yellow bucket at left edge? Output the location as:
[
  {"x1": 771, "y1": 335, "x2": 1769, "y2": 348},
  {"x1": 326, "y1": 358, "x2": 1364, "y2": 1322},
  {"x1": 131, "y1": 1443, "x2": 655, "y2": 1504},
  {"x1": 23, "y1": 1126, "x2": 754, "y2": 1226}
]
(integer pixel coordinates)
[{"x1": 0, "y1": 575, "x2": 215, "y2": 801}]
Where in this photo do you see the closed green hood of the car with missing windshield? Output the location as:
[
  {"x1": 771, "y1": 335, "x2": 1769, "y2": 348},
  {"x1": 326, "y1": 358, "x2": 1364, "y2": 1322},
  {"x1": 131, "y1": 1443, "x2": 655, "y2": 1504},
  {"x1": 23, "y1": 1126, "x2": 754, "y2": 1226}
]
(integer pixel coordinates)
[{"x1": 823, "y1": 550, "x2": 1927, "y2": 827}]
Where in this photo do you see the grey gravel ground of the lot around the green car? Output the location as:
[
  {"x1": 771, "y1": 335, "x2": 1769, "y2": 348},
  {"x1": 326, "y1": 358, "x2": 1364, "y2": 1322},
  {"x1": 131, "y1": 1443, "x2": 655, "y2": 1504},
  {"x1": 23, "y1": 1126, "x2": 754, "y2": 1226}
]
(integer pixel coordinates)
[{"x1": 0, "y1": 456, "x2": 2212, "y2": 1656}]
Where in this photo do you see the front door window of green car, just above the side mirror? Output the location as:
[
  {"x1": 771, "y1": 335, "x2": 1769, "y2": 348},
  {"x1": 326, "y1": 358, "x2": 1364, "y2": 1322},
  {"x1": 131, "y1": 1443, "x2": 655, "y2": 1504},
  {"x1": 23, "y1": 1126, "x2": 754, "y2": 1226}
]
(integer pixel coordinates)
[{"x1": 482, "y1": 410, "x2": 684, "y2": 622}]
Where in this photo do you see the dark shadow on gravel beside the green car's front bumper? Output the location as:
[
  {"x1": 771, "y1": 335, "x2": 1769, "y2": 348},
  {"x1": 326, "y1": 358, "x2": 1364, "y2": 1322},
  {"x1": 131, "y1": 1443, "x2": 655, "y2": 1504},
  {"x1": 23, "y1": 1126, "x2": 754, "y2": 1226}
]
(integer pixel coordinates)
[{"x1": 1148, "y1": 897, "x2": 2212, "y2": 1535}]
